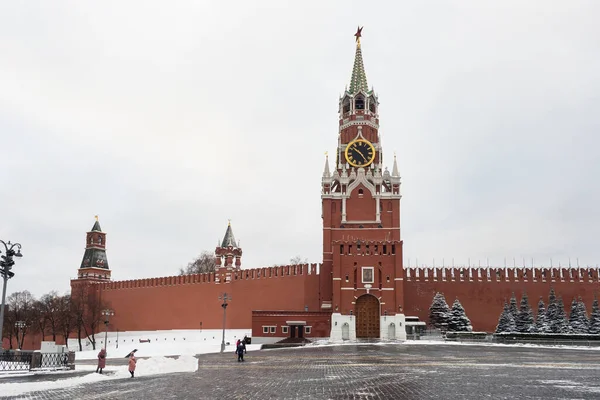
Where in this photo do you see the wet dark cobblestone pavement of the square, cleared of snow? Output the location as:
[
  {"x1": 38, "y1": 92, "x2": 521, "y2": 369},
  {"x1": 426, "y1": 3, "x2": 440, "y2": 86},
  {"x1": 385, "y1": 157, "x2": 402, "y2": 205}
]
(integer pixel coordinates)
[{"x1": 0, "y1": 344, "x2": 600, "y2": 400}]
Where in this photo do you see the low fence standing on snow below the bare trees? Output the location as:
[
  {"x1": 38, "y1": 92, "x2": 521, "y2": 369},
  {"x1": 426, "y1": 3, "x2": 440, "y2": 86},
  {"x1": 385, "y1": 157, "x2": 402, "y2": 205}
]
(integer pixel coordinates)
[{"x1": 0, "y1": 350, "x2": 75, "y2": 373}]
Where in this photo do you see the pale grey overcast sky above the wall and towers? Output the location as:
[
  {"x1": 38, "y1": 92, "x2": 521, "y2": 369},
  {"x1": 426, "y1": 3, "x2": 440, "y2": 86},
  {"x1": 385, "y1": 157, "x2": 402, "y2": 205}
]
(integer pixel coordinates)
[{"x1": 0, "y1": 0, "x2": 600, "y2": 296}]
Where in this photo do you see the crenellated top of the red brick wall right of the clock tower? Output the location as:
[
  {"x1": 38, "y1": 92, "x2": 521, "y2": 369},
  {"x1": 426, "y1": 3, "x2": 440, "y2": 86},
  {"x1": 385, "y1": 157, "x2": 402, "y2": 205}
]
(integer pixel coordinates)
[{"x1": 404, "y1": 267, "x2": 600, "y2": 283}]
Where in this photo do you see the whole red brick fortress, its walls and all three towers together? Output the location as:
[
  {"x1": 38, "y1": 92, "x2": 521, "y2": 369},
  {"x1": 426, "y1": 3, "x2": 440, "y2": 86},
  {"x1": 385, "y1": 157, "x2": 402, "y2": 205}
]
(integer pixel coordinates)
[{"x1": 3, "y1": 28, "x2": 599, "y2": 350}]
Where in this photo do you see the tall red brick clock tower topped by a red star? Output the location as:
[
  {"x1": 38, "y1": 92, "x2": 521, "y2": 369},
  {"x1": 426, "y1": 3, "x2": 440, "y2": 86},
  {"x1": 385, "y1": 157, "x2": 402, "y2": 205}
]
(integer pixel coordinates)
[{"x1": 320, "y1": 28, "x2": 406, "y2": 339}]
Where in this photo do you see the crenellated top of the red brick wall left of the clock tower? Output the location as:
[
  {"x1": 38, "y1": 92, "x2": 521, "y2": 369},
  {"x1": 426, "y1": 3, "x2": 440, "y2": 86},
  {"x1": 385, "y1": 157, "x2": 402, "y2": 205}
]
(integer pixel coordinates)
[{"x1": 98, "y1": 263, "x2": 321, "y2": 290}]
